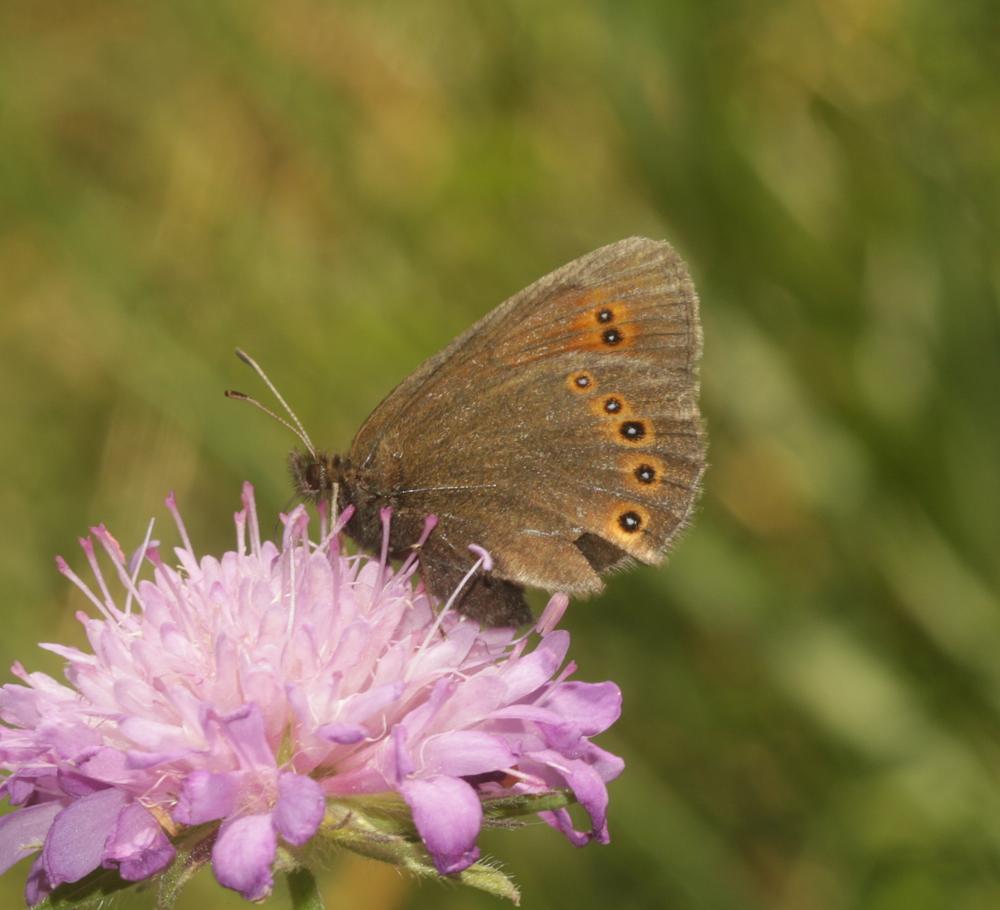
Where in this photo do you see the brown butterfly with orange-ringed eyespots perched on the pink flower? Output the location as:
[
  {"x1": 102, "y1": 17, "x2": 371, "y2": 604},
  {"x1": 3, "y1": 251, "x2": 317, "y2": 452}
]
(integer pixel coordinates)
[{"x1": 227, "y1": 237, "x2": 705, "y2": 626}]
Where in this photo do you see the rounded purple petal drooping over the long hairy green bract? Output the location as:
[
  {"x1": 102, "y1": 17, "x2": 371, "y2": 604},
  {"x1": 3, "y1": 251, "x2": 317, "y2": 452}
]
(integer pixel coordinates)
[{"x1": 399, "y1": 777, "x2": 483, "y2": 875}]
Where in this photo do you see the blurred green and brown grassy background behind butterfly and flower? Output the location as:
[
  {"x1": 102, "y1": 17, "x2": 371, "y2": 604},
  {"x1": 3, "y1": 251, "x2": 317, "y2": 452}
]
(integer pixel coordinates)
[{"x1": 0, "y1": 0, "x2": 1000, "y2": 910}]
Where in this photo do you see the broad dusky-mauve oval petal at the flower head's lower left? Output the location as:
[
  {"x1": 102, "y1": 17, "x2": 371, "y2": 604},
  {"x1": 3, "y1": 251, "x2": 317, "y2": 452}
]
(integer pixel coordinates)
[{"x1": 42, "y1": 788, "x2": 128, "y2": 887}]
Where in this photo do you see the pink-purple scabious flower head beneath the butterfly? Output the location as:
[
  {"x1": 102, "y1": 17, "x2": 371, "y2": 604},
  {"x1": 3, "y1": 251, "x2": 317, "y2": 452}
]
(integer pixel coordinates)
[{"x1": 0, "y1": 485, "x2": 622, "y2": 904}]
